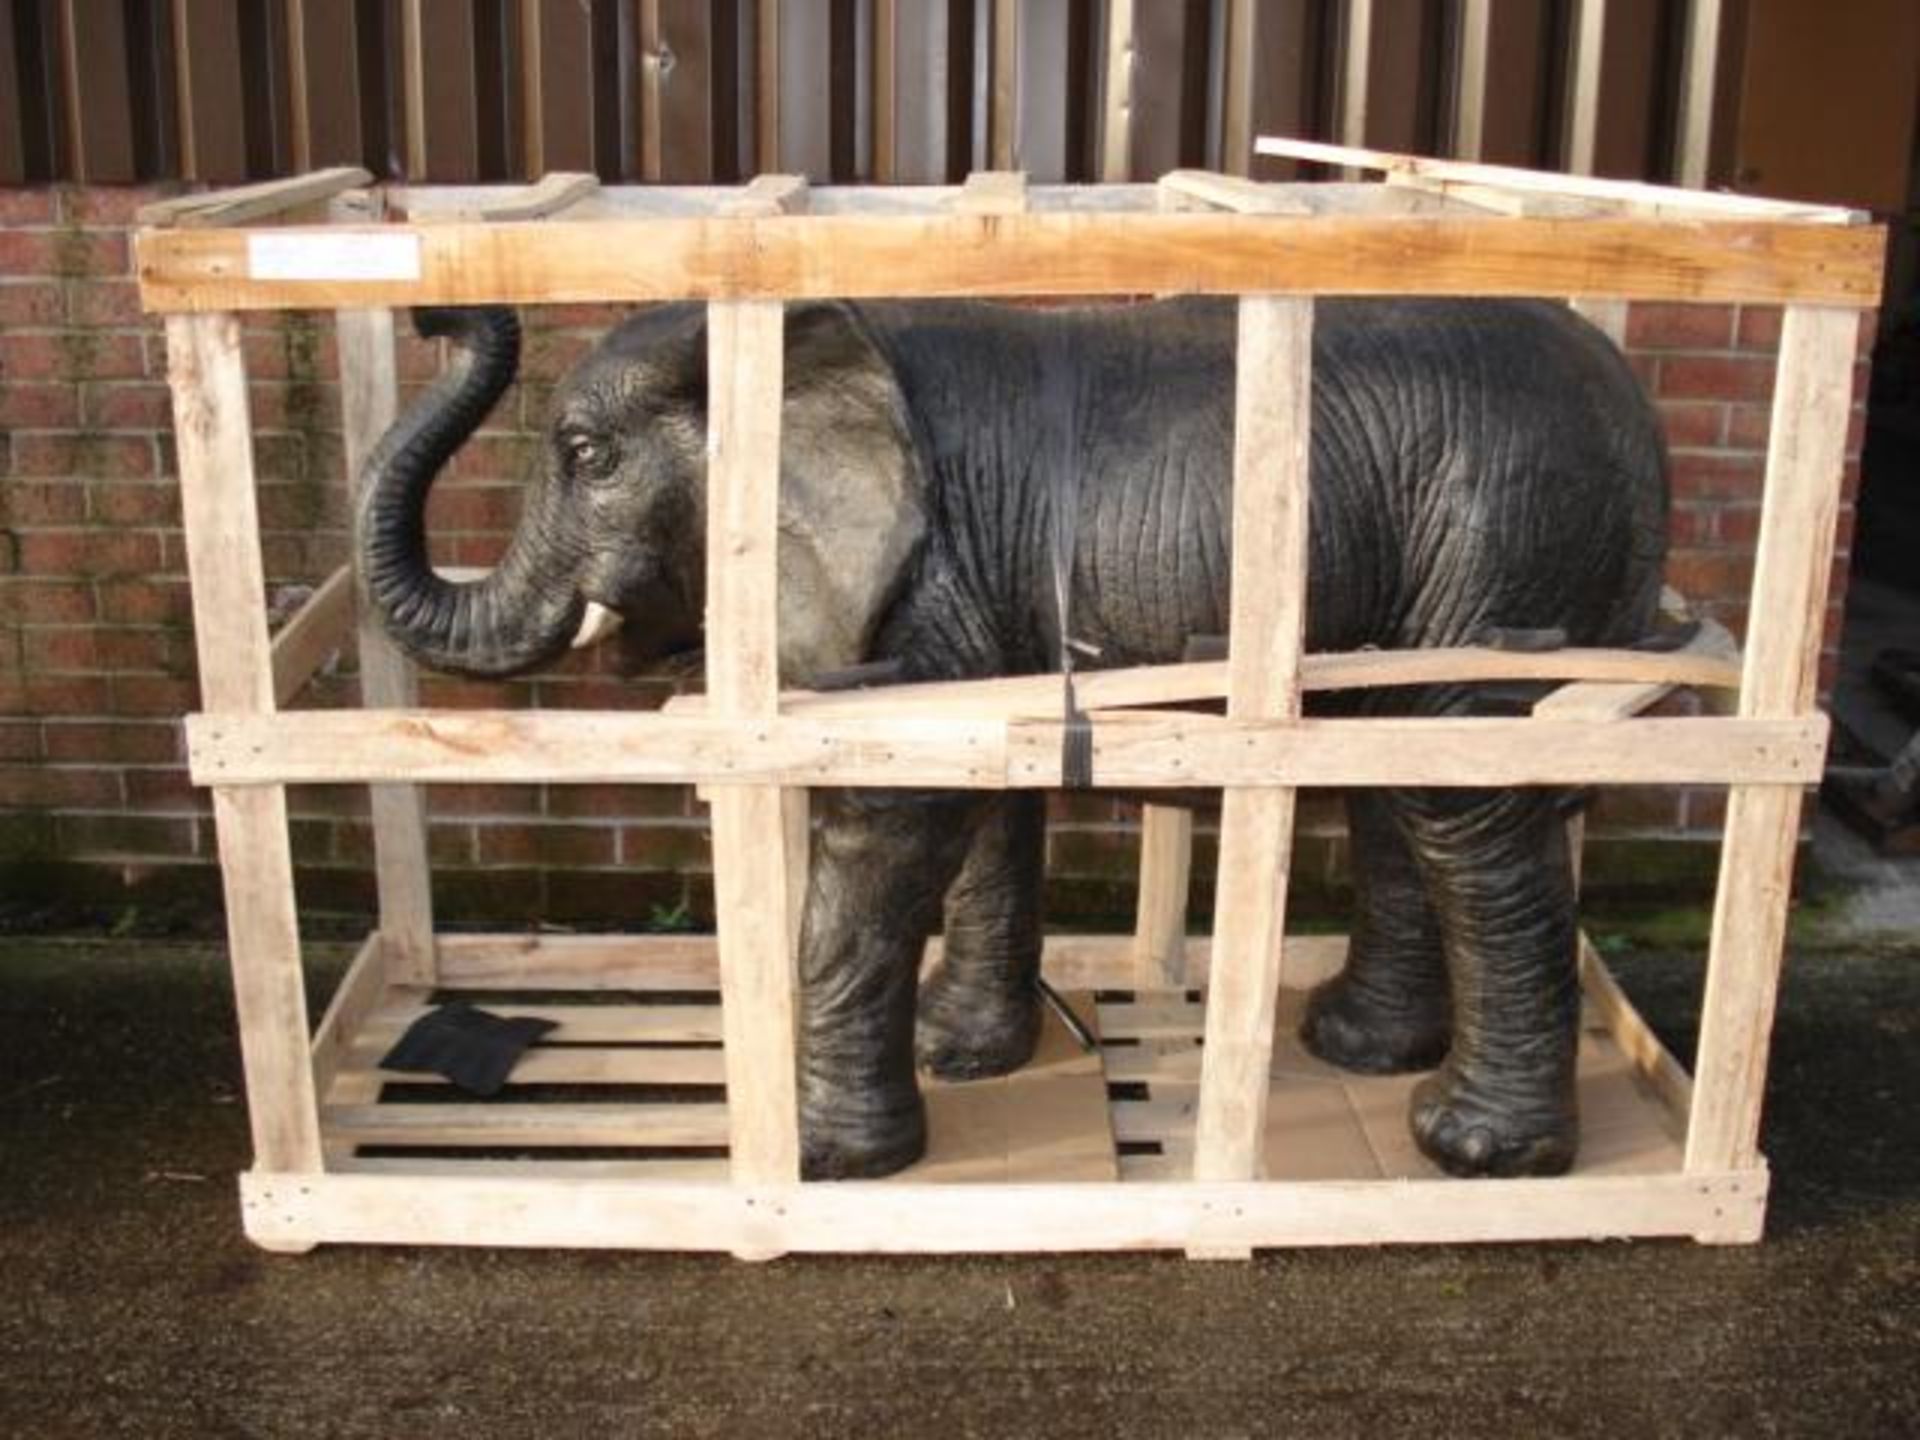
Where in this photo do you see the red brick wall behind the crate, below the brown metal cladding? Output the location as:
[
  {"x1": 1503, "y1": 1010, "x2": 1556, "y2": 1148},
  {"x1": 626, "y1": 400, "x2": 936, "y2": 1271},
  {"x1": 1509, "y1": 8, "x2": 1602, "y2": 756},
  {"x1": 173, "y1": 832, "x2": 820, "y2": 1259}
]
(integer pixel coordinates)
[{"x1": 0, "y1": 188, "x2": 1864, "y2": 925}]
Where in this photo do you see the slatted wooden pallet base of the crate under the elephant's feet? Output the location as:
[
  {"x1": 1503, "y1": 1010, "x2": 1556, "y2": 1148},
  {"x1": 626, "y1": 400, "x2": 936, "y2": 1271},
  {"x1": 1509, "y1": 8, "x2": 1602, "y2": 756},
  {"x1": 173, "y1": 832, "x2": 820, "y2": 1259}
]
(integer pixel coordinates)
[{"x1": 263, "y1": 935, "x2": 1766, "y2": 1256}]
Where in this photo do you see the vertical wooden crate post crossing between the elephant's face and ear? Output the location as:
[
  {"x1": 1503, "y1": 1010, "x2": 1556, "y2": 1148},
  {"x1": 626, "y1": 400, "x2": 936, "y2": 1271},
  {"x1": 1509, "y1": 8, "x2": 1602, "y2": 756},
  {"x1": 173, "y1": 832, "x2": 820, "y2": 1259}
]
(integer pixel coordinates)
[{"x1": 707, "y1": 300, "x2": 801, "y2": 1185}]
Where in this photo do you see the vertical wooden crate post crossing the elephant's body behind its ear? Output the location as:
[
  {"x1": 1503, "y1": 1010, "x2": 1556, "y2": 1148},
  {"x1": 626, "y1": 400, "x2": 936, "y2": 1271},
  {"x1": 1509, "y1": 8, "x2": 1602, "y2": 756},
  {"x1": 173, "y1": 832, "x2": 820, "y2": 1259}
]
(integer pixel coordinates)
[{"x1": 1194, "y1": 296, "x2": 1313, "y2": 1213}]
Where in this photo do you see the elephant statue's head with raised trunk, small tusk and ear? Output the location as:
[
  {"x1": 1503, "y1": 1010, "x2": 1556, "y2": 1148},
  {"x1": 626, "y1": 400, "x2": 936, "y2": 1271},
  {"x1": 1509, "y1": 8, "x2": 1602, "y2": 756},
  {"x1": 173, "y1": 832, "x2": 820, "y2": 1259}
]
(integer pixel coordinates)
[{"x1": 355, "y1": 305, "x2": 925, "y2": 684}]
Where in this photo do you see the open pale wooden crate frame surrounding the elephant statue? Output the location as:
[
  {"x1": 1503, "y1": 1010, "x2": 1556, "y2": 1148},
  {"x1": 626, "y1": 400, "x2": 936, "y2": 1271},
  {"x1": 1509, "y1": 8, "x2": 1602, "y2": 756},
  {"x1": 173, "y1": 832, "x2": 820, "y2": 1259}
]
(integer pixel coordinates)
[{"x1": 138, "y1": 142, "x2": 1884, "y2": 1258}]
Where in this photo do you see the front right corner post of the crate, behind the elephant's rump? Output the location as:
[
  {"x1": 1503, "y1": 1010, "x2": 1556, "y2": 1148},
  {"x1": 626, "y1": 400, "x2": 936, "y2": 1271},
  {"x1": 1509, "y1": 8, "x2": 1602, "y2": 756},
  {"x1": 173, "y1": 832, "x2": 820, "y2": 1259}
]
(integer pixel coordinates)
[{"x1": 1686, "y1": 305, "x2": 1860, "y2": 1240}]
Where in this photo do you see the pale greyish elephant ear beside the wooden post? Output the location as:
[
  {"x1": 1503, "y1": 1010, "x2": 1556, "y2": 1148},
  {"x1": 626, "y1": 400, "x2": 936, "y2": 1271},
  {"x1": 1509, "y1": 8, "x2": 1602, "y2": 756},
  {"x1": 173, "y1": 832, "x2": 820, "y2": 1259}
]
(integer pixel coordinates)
[{"x1": 780, "y1": 305, "x2": 927, "y2": 685}]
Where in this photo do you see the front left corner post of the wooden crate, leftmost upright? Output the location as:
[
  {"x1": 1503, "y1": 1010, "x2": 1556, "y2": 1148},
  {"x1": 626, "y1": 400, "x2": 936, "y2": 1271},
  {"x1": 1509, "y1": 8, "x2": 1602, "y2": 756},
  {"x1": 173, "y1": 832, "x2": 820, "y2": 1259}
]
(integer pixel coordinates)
[{"x1": 167, "y1": 315, "x2": 321, "y2": 1205}]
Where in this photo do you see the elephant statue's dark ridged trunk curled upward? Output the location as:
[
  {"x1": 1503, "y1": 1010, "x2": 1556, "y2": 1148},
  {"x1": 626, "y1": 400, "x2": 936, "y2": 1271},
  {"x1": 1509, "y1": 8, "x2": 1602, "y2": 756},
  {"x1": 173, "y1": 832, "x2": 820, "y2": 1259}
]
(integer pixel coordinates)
[{"x1": 355, "y1": 307, "x2": 586, "y2": 676}]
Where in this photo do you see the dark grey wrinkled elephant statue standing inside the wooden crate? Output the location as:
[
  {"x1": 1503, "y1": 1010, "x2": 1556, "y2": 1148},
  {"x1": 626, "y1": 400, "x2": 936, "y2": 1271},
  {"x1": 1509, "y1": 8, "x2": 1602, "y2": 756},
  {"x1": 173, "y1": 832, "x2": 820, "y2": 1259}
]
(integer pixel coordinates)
[{"x1": 355, "y1": 298, "x2": 1667, "y2": 1179}]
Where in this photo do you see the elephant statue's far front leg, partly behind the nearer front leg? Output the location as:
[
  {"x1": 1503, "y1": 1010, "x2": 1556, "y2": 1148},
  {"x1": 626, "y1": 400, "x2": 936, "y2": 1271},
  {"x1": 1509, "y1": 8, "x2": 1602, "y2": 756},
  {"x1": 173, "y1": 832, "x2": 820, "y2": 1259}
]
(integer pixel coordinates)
[{"x1": 914, "y1": 793, "x2": 1046, "y2": 1079}]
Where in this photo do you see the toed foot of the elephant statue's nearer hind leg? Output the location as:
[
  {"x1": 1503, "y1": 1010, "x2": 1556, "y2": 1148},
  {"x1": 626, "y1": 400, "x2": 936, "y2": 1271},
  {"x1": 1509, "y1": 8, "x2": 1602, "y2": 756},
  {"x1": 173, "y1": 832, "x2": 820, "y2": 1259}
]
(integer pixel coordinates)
[{"x1": 1407, "y1": 1066, "x2": 1580, "y2": 1177}]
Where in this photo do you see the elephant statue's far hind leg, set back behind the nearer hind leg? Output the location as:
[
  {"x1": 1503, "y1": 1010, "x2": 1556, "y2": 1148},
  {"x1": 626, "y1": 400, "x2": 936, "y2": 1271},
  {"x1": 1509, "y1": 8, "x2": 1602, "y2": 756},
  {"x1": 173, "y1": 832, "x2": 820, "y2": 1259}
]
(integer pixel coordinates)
[{"x1": 1300, "y1": 789, "x2": 1452, "y2": 1075}]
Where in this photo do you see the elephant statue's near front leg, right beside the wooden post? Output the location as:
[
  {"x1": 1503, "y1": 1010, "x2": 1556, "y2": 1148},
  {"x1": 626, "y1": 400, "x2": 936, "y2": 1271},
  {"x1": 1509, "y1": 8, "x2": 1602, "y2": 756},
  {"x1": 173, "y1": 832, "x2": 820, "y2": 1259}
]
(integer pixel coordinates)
[{"x1": 799, "y1": 791, "x2": 979, "y2": 1179}]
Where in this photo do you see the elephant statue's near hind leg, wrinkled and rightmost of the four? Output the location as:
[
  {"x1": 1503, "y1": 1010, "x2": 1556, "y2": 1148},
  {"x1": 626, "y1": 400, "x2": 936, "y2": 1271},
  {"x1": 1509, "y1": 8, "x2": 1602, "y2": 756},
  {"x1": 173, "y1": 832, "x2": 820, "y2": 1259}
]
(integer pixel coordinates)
[{"x1": 1394, "y1": 789, "x2": 1580, "y2": 1175}]
